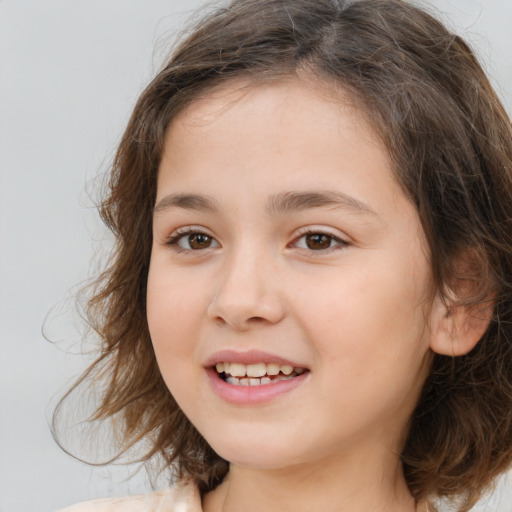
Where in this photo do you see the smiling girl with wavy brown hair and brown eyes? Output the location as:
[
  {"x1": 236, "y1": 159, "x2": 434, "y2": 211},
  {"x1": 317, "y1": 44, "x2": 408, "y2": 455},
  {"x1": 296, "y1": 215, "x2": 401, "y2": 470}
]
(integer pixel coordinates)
[{"x1": 56, "y1": 0, "x2": 512, "y2": 512}]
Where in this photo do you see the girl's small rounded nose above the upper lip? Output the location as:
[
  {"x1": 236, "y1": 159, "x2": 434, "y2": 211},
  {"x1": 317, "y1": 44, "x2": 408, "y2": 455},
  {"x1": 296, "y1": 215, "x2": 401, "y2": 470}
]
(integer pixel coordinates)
[{"x1": 207, "y1": 245, "x2": 286, "y2": 331}]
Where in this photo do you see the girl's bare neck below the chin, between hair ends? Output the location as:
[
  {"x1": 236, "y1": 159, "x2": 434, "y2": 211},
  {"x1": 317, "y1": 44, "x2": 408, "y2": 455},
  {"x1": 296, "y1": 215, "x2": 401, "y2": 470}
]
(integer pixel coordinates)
[{"x1": 204, "y1": 444, "x2": 419, "y2": 512}]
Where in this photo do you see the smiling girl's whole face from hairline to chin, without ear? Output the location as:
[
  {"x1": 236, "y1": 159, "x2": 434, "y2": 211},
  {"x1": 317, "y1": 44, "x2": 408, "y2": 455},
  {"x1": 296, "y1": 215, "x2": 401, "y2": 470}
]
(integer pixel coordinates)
[{"x1": 147, "y1": 80, "x2": 432, "y2": 468}]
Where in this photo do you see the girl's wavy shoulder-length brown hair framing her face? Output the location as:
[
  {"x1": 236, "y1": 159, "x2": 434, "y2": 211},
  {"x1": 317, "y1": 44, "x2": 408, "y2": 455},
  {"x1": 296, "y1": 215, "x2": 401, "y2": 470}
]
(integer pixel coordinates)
[{"x1": 53, "y1": 0, "x2": 512, "y2": 511}]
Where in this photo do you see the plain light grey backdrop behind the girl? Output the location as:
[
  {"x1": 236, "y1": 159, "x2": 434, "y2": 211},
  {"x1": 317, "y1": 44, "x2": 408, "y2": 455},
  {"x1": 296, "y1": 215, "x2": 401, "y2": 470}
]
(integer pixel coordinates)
[{"x1": 0, "y1": 0, "x2": 512, "y2": 512}]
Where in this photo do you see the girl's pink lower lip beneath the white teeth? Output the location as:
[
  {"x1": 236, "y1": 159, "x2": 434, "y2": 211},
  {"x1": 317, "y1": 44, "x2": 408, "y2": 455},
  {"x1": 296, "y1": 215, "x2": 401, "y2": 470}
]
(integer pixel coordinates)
[{"x1": 206, "y1": 368, "x2": 309, "y2": 405}]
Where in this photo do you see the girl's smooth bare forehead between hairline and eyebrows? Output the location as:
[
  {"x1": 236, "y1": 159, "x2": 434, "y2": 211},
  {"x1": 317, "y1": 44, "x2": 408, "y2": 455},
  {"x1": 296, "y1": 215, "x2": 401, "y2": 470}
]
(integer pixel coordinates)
[{"x1": 157, "y1": 79, "x2": 416, "y2": 234}]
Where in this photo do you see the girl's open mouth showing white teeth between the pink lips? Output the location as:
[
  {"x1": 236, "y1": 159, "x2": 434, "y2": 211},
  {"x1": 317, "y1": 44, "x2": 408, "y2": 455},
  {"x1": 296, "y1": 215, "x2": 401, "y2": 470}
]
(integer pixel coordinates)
[{"x1": 213, "y1": 362, "x2": 308, "y2": 386}]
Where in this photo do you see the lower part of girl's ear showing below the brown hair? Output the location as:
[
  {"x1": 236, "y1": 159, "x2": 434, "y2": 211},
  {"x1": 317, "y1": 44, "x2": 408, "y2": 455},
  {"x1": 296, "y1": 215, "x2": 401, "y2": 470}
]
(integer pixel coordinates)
[{"x1": 430, "y1": 296, "x2": 493, "y2": 357}]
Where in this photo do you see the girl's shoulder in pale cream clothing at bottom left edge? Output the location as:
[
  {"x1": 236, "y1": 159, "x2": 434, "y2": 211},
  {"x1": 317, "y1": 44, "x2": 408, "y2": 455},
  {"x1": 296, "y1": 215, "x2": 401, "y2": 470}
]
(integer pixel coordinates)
[{"x1": 59, "y1": 482, "x2": 202, "y2": 512}]
